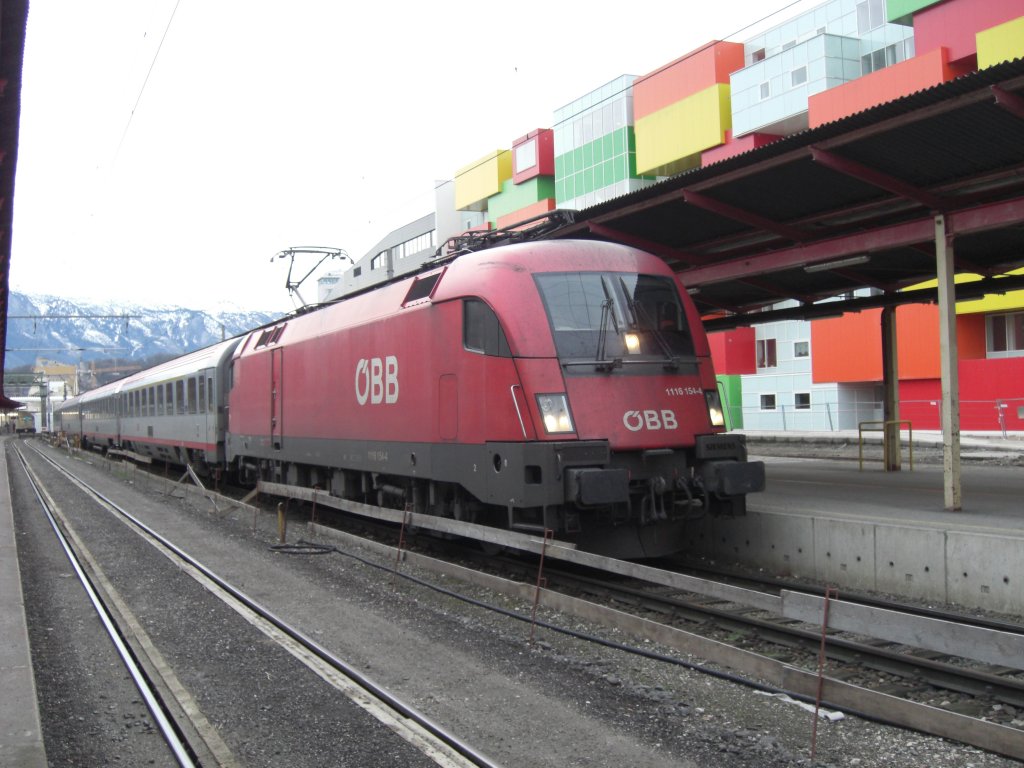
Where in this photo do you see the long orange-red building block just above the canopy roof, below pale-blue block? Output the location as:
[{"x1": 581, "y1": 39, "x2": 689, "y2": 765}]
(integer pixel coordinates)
[{"x1": 807, "y1": 48, "x2": 964, "y2": 128}]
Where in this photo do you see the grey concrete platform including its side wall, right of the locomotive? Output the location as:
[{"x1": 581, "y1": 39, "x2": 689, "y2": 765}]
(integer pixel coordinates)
[{"x1": 687, "y1": 430, "x2": 1024, "y2": 616}]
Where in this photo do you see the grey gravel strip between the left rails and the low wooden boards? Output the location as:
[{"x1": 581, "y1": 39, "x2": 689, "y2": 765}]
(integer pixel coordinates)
[{"x1": 16, "y1": 438, "x2": 1019, "y2": 768}]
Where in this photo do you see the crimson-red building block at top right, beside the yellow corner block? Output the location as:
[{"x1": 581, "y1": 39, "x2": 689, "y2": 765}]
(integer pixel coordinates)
[{"x1": 913, "y1": 0, "x2": 1024, "y2": 69}]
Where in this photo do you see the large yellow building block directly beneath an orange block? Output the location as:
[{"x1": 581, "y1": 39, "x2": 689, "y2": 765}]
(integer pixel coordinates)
[{"x1": 636, "y1": 83, "x2": 732, "y2": 176}]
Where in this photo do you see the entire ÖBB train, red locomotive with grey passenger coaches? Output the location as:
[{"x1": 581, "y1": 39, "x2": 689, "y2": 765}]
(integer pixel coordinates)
[{"x1": 55, "y1": 241, "x2": 764, "y2": 558}]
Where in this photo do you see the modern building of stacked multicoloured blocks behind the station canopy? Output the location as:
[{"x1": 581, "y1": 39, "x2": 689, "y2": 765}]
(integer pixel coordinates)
[{"x1": 331, "y1": 0, "x2": 1024, "y2": 431}]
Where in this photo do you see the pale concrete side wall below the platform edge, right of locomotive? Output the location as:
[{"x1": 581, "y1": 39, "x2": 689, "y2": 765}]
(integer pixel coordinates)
[{"x1": 686, "y1": 512, "x2": 1024, "y2": 615}]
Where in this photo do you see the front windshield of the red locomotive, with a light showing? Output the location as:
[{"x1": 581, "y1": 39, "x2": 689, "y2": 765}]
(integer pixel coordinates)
[{"x1": 536, "y1": 272, "x2": 693, "y2": 368}]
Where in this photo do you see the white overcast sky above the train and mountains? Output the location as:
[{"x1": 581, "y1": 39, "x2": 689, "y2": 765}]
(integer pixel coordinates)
[{"x1": 10, "y1": 0, "x2": 815, "y2": 311}]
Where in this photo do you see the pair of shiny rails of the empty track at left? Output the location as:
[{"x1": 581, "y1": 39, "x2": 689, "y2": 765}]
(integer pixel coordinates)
[{"x1": 13, "y1": 438, "x2": 498, "y2": 768}]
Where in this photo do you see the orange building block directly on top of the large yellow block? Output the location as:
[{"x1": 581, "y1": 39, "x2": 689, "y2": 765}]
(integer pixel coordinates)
[{"x1": 633, "y1": 41, "x2": 743, "y2": 120}]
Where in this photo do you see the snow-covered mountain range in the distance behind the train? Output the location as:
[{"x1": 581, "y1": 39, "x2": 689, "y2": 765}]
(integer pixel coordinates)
[{"x1": 5, "y1": 292, "x2": 281, "y2": 369}]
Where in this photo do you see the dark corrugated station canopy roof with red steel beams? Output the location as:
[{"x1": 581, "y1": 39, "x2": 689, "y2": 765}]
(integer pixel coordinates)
[{"x1": 548, "y1": 59, "x2": 1024, "y2": 330}]
